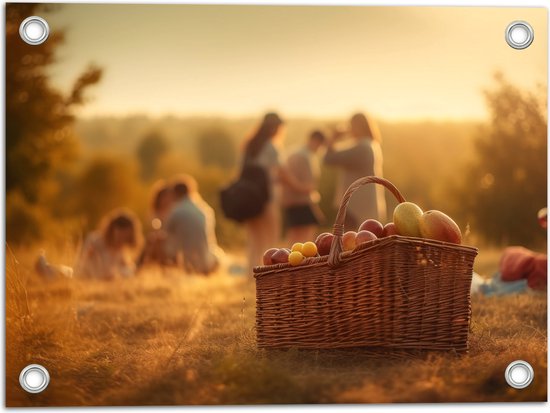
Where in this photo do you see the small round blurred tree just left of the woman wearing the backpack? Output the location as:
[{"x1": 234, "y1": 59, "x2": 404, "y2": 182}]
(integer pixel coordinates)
[{"x1": 197, "y1": 127, "x2": 237, "y2": 169}]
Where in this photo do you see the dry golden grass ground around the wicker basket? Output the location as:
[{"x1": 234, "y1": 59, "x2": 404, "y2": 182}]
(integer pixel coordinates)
[{"x1": 6, "y1": 245, "x2": 547, "y2": 406}]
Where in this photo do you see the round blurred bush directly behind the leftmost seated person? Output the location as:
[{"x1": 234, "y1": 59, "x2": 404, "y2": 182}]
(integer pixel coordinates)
[{"x1": 75, "y1": 155, "x2": 141, "y2": 230}]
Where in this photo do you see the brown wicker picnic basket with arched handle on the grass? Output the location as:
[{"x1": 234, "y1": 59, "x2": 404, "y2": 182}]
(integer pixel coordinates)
[{"x1": 254, "y1": 176, "x2": 477, "y2": 352}]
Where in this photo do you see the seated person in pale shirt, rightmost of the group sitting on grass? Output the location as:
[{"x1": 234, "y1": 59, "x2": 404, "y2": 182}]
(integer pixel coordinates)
[{"x1": 165, "y1": 175, "x2": 220, "y2": 275}]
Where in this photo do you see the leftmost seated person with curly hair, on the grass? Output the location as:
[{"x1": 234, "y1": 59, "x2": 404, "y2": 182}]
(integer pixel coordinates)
[{"x1": 76, "y1": 209, "x2": 142, "y2": 280}]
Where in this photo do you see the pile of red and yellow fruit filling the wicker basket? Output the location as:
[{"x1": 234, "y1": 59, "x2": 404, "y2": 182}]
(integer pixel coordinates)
[{"x1": 263, "y1": 202, "x2": 462, "y2": 266}]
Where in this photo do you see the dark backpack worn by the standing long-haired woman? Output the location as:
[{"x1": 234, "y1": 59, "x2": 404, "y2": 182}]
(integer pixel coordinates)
[{"x1": 220, "y1": 163, "x2": 270, "y2": 222}]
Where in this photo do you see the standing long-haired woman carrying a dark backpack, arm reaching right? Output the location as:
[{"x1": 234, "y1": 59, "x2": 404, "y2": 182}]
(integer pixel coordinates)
[{"x1": 243, "y1": 112, "x2": 313, "y2": 271}]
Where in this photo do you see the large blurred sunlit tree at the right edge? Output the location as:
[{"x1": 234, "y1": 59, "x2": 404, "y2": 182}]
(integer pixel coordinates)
[{"x1": 457, "y1": 73, "x2": 548, "y2": 246}]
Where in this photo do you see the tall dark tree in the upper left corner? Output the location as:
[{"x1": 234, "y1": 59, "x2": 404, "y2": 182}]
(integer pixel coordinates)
[{"x1": 6, "y1": 3, "x2": 101, "y2": 203}]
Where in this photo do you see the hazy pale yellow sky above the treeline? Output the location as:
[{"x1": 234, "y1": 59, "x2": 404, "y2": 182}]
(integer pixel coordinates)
[{"x1": 47, "y1": 4, "x2": 547, "y2": 119}]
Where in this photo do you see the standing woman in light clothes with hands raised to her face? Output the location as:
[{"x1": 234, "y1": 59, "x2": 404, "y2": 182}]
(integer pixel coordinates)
[{"x1": 324, "y1": 113, "x2": 386, "y2": 231}]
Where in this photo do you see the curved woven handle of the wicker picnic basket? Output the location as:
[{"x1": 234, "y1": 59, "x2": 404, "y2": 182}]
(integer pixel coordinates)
[{"x1": 328, "y1": 176, "x2": 405, "y2": 268}]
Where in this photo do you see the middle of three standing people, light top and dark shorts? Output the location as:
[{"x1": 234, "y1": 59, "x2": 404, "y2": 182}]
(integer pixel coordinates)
[{"x1": 281, "y1": 130, "x2": 325, "y2": 245}]
